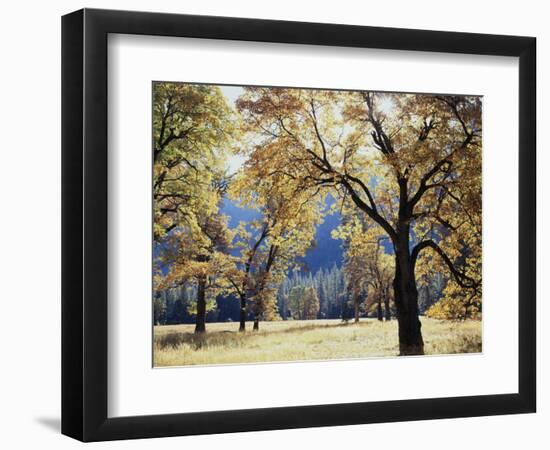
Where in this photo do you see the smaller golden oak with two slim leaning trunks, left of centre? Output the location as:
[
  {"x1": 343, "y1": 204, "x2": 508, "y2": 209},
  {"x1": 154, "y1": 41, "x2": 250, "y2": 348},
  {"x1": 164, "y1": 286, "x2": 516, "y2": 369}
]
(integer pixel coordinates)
[{"x1": 230, "y1": 162, "x2": 321, "y2": 331}]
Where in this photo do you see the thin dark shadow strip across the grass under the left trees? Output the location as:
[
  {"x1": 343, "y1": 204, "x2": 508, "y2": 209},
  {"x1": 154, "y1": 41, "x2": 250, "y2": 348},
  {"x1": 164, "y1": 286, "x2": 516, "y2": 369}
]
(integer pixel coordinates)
[{"x1": 155, "y1": 321, "x2": 378, "y2": 350}]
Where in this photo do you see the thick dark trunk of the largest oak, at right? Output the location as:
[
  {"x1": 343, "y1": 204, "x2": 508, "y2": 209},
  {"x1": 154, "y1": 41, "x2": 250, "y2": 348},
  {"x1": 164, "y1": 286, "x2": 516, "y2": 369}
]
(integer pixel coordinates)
[{"x1": 393, "y1": 232, "x2": 424, "y2": 356}]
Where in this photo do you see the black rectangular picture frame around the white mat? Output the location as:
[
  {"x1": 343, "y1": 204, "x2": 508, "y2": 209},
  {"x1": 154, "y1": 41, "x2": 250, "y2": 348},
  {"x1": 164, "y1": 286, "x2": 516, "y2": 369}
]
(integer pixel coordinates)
[{"x1": 62, "y1": 9, "x2": 536, "y2": 441}]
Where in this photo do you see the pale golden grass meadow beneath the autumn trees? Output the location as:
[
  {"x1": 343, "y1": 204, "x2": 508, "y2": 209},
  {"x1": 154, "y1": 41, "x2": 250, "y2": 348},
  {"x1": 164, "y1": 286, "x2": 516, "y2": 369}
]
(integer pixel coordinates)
[{"x1": 153, "y1": 318, "x2": 481, "y2": 367}]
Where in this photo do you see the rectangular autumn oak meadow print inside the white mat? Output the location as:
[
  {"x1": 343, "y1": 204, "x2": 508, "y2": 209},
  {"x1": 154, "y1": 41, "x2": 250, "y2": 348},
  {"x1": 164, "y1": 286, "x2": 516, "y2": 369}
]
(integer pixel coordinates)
[{"x1": 152, "y1": 81, "x2": 482, "y2": 367}]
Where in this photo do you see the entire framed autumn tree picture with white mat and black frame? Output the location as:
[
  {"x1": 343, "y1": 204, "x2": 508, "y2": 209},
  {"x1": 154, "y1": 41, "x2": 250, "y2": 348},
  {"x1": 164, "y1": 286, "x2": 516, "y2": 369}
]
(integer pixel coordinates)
[{"x1": 62, "y1": 9, "x2": 536, "y2": 441}]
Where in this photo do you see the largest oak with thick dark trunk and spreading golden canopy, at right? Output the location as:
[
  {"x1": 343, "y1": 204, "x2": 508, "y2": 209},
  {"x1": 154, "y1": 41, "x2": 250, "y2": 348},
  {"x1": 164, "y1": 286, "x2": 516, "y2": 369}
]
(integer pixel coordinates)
[{"x1": 237, "y1": 88, "x2": 481, "y2": 355}]
